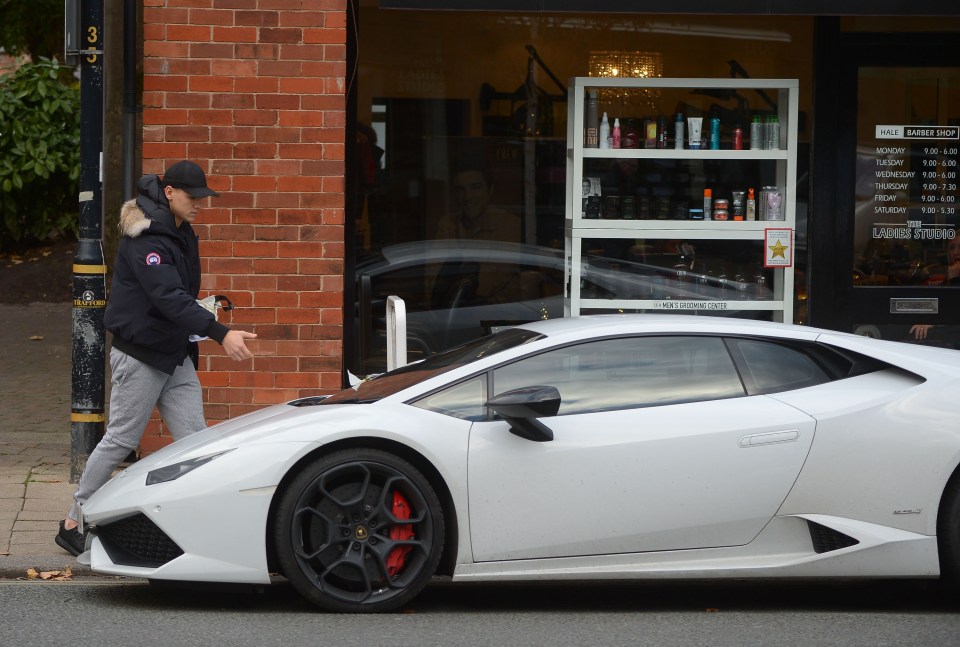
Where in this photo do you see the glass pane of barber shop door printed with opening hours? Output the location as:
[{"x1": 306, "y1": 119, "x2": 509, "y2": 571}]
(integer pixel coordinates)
[{"x1": 851, "y1": 65, "x2": 960, "y2": 346}]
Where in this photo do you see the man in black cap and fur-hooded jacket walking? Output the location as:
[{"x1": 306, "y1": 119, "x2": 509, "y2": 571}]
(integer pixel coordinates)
[{"x1": 56, "y1": 161, "x2": 256, "y2": 555}]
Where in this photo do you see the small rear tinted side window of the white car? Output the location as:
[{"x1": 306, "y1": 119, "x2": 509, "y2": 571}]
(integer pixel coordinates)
[{"x1": 730, "y1": 339, "x2": 831, "y2": 393}]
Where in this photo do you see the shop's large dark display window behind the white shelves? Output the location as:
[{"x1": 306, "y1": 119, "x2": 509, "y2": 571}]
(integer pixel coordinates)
[{"x1": 346, "y1": 7, "x2": 813, "y2": 375}]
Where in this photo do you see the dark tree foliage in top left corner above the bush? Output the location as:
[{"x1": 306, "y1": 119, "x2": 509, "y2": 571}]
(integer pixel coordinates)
[{"x1": 0, "y1": 0, "x2": 63, "y2": 60}]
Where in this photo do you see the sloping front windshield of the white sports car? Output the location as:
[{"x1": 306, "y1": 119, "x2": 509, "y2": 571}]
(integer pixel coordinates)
[{"x1": 318, "y1": 328, "x2": 543, "y2": 404}]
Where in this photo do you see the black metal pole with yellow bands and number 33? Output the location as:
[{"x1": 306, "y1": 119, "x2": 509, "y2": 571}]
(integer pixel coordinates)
[{"x1": 70, "y1": 0, "x2": 107, "y2": 483}]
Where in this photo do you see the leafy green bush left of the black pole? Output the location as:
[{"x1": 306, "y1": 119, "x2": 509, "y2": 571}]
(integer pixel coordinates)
[{"x1": 0, "y1": 58, "x2": 80, "y2": 249}]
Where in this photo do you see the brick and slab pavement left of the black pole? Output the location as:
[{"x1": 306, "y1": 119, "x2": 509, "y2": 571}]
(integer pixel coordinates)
[{"x1": 0, "y1": 302, "x2": 91, "y2": 579}]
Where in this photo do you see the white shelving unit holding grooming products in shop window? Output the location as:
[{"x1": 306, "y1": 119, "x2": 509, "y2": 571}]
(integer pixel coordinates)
[{"x1": 565, "y1": 77, "x2": 798, "y2": 322}]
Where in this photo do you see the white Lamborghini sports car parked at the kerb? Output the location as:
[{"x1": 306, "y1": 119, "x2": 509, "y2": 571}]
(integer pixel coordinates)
[{"x1": 81, "y1": 315, "x2": 960, "y2": 612}]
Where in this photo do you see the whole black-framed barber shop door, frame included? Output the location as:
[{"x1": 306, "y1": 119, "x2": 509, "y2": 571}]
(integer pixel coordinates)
[{"x1": 811, "y1": 33, "x2": 960, "y2": 348}]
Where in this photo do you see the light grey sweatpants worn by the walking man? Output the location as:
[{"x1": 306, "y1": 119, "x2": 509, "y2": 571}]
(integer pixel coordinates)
[{"x1": 68, "y1": 348, "x2": 207, "y2": 520}]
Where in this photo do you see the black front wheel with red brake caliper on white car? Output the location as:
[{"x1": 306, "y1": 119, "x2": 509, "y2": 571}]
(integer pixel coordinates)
[{"x1": 274, "y1": 449, "x2": 444, "y2": 613}]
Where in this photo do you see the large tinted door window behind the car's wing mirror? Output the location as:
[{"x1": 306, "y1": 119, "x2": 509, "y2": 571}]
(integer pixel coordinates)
[{"x1": 493, "y1": 336, "x2": 744, "y2": 415}]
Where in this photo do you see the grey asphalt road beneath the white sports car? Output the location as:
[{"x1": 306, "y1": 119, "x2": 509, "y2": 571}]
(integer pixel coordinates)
[{"x1": 0, "y1": 578, "x2": 960, "y2": 647}]
